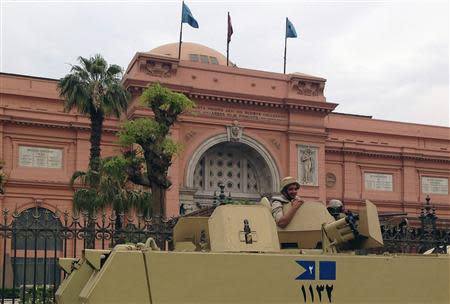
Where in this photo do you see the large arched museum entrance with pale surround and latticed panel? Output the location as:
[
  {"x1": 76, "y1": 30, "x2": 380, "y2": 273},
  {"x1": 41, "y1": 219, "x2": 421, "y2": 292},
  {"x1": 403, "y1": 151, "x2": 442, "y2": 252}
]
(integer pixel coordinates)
[{"x1": 180, "y1": 134, "x2": 279, "y2": 210}]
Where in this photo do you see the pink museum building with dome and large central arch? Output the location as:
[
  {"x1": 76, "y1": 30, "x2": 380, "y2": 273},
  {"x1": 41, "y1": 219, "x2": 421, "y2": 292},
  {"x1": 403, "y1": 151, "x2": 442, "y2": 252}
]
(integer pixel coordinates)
[{"x1": 0, "y1": 43, "x2": 450, "y2": 219}]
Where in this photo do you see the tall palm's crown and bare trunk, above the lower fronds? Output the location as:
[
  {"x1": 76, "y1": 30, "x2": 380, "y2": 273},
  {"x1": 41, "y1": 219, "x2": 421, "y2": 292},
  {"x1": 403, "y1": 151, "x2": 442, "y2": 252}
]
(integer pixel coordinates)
[{"x1": 58, "y1": 54, "x2": 130, "y2": 171}]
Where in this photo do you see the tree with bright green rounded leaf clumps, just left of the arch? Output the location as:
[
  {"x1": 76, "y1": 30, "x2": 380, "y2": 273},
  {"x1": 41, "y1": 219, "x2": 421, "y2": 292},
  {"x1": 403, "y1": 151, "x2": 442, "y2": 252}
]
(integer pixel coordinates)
[{"x1": 119, "y1": 83, "x2": 195, "y2": 217}]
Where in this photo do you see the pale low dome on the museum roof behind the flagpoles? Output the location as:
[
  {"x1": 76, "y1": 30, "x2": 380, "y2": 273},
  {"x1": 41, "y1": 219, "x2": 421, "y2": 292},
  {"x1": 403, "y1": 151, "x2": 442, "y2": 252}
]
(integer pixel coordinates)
[{"x1": 149, "y1": 42, "x2": 227, "y2": 65}]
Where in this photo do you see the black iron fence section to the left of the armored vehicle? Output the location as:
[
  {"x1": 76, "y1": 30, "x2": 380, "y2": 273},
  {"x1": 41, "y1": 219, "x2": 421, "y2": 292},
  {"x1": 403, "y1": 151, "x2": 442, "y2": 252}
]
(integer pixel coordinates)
[{"x1": 0, "y1": 207, "x2": 176, "y2": 304}]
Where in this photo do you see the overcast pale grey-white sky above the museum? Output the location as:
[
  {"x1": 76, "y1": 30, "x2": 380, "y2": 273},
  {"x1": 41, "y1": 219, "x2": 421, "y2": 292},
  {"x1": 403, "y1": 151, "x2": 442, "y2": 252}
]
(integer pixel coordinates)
[{"x1": 0, "y1": 0, "x2": 450, "y2": 126}]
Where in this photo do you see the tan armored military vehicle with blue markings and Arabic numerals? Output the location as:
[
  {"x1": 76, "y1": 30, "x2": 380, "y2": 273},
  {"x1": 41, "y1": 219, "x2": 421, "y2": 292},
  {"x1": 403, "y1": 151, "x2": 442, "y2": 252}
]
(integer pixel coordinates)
[{"x1": 56, "y1": 199, "x2": 450, "y2": 304}]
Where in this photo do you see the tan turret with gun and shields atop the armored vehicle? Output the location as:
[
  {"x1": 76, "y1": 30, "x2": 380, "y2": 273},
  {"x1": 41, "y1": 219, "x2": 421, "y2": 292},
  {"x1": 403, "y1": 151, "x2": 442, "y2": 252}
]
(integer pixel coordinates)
[{"x1": 174, "y1": 199, "x2": 383, "y2": 252}]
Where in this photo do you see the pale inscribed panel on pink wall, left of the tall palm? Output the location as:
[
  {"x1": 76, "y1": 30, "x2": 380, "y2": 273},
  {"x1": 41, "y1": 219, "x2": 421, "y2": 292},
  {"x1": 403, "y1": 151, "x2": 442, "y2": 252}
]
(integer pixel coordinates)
[{"x1": 19, "y1": 146, "x2": 63, "y2": 169}]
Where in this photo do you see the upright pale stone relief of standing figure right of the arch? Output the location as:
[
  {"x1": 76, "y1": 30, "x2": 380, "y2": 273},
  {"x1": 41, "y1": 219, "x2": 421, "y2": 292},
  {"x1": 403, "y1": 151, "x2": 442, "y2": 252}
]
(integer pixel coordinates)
[{"x1": 298, "y1": 145, "x2": 319, "y2": 186}]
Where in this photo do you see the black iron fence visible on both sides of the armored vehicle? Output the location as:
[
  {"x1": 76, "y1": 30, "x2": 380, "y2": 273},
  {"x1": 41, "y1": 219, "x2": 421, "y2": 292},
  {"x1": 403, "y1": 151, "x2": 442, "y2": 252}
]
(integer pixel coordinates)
[{"x1": 0, "y1": 199, "x2": 450, "y2": 304}]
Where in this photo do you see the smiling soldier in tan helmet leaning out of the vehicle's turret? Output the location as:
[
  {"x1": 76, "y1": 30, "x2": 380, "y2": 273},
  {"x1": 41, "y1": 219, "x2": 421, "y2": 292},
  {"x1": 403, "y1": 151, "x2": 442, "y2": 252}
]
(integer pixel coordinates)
[{"x1": 271, "y1": 176, "x2": 304, "y2": 228}]
